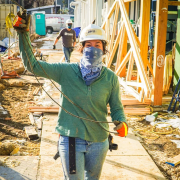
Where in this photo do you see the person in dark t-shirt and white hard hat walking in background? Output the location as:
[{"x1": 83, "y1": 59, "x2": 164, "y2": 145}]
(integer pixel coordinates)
[{"x1": 53, "y1": 19, "x2": 76, "y2": 63}]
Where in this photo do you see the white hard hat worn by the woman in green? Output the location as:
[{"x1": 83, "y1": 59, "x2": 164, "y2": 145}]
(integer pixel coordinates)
[{"x1": 80, "y1": 24, "x2": 107, "y2": 42}]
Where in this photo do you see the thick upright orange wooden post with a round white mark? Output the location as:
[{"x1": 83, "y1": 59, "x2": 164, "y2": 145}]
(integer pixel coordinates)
[{"x1": 153, "y1": 0, "x2": 168, "y2": 105}]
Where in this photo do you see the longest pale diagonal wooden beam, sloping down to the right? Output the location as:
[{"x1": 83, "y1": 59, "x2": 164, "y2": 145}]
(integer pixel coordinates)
[{"x1": 119, "y1": 0, "x2": 151, "y2": 96}]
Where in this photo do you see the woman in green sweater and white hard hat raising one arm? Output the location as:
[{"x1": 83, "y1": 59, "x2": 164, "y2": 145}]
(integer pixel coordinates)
[{"x1": 15, "y1": 10, "x2": 127, "y2": 180}]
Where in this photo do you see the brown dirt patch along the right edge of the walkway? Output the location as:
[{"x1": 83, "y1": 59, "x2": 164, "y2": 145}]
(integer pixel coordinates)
[{"x1": 127, "y1": 112, "x2": 180, "y2": 180}]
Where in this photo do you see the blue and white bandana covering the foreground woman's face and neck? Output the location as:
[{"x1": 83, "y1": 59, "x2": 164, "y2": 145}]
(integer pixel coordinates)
[{"x1": 80, "y1": 47, "x2": 103, "y2": 86}]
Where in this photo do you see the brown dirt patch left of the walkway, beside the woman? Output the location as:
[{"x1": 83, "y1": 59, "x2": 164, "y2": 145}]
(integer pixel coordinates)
[{"x1": 0, "y1": 80, "x2": 40, "y2": 156}]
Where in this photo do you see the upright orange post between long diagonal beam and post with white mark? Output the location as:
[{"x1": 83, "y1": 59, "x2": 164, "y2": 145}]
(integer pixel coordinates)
[{"x1": 139, "y1": 0, "x2": 151, "y2": 70}]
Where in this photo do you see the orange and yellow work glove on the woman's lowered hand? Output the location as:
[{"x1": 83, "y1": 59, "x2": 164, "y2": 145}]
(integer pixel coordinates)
[{"x1": 113, "y1": 120, "x2": 128, "y2": 137}]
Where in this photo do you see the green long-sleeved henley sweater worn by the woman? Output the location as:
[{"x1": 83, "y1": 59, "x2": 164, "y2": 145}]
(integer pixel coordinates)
[{"x1": 19, "y1": 32, "x2": 127, "y2": 142}]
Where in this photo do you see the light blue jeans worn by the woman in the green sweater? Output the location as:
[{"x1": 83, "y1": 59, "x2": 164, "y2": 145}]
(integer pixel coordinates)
[{"x1": 59, "y1": 136, "x2": 109, "y2": 180}]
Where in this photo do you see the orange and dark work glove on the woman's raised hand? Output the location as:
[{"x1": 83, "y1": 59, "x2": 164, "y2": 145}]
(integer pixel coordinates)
[{"x1": 13, "y1": 9, "x2": 31, "y2": 32}]
